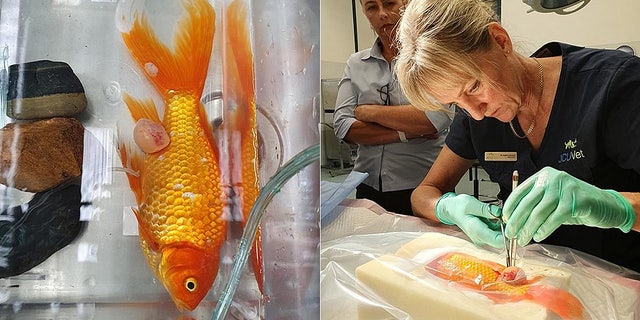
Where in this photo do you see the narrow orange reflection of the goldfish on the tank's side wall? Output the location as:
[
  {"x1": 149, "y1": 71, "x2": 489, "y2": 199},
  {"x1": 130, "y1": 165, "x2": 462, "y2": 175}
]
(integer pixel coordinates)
[{"x1": 224, "y1": 0, "x2": 264, "y2": 292}]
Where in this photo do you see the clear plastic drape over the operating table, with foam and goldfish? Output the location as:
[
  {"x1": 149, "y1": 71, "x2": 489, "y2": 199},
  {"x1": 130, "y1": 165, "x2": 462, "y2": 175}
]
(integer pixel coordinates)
[{"x1": 321, "y1": 200, "x2": 640, "y2": 319}]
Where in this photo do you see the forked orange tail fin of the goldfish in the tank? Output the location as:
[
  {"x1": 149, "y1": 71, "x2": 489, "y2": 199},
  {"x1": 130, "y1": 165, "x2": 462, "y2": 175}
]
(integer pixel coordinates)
[{"x1": 122, "y1": 0, "x2": 215, "y2": 97}]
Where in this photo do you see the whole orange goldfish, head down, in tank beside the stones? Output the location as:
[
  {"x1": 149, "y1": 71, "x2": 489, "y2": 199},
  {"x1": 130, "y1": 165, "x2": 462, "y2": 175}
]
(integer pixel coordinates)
[{"x1": 119, "y1": 0, "x2": 226, "y2": 311}]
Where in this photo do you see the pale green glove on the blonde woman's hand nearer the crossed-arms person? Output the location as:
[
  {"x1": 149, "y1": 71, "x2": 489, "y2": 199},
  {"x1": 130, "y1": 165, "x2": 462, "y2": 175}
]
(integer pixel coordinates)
[{"x1": 436, "y1": 192, "x2": 504, "y2": 248}]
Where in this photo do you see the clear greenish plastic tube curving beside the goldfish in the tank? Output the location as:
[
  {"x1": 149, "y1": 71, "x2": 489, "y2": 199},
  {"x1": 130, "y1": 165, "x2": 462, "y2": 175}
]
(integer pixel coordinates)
[{"x1": 211, "y1": 144, "x2": 320, "y2": 319}]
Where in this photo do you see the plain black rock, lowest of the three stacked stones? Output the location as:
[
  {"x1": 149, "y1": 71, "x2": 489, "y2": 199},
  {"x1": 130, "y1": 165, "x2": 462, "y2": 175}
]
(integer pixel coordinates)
[{"x1": 0, "y1": 179, "x2": 84, "y2": 278}]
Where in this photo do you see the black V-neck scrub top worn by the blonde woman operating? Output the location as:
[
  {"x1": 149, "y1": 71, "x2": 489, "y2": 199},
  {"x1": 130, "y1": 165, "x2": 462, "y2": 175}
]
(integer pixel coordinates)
[{"x1": 446, "y1": 43, "x2": 640, "y2": 272}]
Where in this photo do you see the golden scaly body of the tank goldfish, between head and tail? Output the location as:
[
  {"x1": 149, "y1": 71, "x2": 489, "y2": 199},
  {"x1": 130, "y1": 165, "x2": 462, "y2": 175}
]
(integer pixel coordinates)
[{"x1": 140, "y1": 93, "x2": 224, "y2": 247}]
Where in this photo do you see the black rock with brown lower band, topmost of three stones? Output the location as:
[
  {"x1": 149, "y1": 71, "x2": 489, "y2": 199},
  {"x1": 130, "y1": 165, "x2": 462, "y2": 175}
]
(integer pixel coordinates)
[{"x1": 7, "y1": 60, "x2": 87, "y2": 120}]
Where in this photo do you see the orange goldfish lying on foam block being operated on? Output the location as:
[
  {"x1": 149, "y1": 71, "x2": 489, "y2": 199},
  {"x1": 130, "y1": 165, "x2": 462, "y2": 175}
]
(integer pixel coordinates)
[{"x1": 425, "y1": 252, "x2": 585, "y2": 319}]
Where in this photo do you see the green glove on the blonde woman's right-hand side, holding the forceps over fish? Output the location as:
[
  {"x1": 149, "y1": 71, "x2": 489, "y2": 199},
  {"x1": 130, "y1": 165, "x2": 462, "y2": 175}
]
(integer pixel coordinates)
[{"x1": 502, "y1": 167, "x2": 636, "y2": 246}]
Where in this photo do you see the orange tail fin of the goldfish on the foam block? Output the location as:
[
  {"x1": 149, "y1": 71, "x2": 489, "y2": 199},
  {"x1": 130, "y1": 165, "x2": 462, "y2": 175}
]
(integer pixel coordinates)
[{"x1": 526, "y1": 285, "x2": 587, "y2": 319}]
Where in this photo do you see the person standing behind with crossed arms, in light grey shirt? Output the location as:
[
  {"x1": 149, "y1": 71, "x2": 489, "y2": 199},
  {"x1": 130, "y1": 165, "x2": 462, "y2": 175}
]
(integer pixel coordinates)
[{"x1": 334, "y1": 0, "x2": 453, "y2": 215}]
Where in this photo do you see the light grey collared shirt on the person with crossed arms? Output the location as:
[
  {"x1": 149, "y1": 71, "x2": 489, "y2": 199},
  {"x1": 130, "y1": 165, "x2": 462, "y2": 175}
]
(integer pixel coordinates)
[{"x1": 334, "y1": 39, "x2": 453, "y2": 192}]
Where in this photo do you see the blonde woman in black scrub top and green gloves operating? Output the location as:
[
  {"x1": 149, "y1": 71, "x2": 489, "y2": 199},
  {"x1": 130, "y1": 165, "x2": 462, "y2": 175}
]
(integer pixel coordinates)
[{"x1": 397, "y1": 0, "x2": 640, "y2": 271}]
